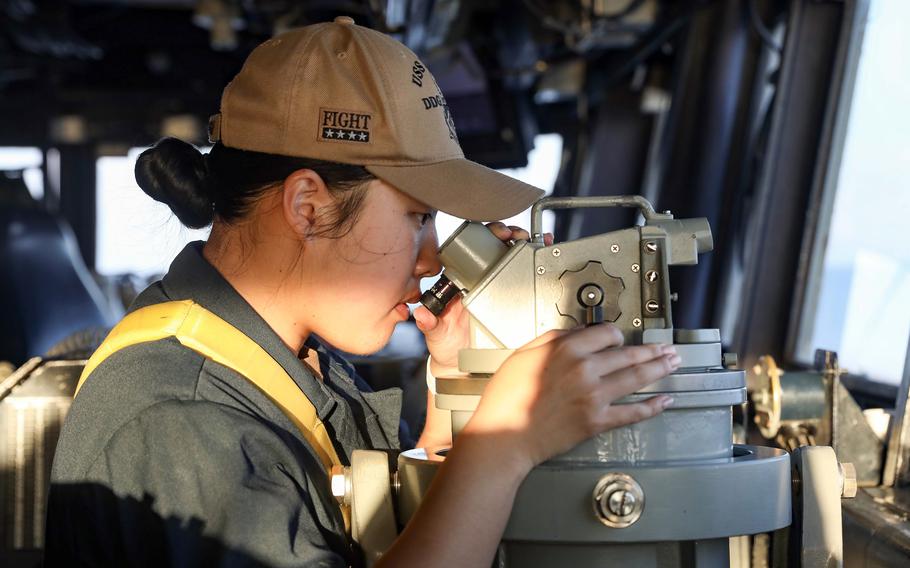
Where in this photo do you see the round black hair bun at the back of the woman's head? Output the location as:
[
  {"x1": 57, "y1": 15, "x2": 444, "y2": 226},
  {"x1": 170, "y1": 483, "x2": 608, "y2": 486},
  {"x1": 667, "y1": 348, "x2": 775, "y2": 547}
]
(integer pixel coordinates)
[{"x1": 135, "y1": 138, "x2": 215, "y2": 229}]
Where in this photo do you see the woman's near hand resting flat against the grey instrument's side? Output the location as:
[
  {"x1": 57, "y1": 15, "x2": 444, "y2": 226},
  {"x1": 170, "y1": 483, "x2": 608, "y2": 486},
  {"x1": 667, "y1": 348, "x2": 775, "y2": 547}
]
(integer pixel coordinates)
[{"x1": 461, "y1": 324, "x2": 680, "y2": 471}]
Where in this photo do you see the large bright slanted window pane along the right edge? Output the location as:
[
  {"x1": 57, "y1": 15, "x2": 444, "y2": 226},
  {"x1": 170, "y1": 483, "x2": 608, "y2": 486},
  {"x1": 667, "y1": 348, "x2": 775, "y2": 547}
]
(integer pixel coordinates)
[{"x1": 796, "y1": 0, "x2": 910, "y2": 384}]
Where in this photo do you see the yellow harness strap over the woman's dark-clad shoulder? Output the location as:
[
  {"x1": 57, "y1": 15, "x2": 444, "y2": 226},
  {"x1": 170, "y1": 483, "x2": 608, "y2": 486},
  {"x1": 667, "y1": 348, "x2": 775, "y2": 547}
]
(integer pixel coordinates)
[{"x1": 76, "y1": 300, "x2": 350, "y2": 526}]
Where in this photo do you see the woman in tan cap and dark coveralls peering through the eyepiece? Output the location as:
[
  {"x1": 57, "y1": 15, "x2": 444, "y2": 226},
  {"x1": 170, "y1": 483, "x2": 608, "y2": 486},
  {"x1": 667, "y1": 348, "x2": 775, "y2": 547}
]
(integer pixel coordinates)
[{"x1": 47, "y1": 18, "x2": 679, "y2": 567}]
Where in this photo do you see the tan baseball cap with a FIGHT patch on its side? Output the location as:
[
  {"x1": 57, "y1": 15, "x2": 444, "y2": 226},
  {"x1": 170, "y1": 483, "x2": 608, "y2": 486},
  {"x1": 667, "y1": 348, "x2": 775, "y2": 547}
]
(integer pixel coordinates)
[{"x1": 209, "y1": 16, "x2": 543, "y2": 221}]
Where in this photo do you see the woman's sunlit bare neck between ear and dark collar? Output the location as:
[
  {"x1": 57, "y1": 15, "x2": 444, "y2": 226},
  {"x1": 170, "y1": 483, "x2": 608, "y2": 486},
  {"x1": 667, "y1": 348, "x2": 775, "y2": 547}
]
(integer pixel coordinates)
[{"x1": 202, "y1": 221, "x2": 318, "y2": 356}]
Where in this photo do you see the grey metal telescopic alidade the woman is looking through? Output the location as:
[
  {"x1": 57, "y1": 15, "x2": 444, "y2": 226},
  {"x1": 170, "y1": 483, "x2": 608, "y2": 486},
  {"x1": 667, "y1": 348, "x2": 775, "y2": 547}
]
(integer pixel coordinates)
[{"x1": 334, "y1": 196, "x2": 850, "y2": 567}]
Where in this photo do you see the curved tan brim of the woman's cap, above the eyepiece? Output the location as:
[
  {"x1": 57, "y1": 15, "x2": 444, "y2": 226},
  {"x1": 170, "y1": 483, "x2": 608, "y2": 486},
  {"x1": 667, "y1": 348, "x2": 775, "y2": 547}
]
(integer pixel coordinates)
[{"x1": 365, "y1": 158, "x2": 544, "y2": 221}]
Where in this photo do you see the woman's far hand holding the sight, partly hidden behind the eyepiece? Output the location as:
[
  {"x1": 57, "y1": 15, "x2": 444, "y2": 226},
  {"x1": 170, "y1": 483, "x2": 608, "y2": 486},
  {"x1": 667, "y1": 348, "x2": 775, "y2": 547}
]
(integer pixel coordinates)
[{"x1": 414, "y1": 221, "x2": 553, "y2": 377}]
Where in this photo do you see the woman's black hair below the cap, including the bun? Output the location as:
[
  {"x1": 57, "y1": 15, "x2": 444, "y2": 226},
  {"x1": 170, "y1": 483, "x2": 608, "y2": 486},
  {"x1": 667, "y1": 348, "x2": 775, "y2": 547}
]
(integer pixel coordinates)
[{"x1": 136, "y1": 138, "x2": 376, "y2": 237}]
